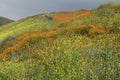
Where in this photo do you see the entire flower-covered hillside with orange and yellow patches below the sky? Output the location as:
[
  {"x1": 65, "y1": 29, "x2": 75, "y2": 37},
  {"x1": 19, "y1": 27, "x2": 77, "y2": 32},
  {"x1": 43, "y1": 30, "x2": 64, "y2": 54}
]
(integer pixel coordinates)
[{"x1": 0, "y1": 4, "x2": 120, "y2": 80}]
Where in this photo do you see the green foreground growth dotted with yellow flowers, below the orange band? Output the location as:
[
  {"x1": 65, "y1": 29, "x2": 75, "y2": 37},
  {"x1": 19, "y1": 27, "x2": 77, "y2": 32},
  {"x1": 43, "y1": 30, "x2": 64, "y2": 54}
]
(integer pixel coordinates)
[{"x1": 0, "y1": 35, "x2": 120, "y2": 80}]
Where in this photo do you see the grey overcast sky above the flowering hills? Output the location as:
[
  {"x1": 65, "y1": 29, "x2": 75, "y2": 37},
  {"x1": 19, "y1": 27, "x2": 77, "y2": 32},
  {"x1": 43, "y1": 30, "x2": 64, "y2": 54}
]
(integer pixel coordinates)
[{"x1": 0, "y1": 0, "x2": 118, "y2": 20}]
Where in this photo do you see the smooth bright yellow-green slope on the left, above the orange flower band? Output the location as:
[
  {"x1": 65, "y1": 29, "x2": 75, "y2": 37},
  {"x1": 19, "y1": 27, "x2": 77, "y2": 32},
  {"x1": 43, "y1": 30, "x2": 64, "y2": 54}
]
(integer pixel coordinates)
[{"x1": 0, "y1": 15, "x2": 55, "y2": 41}]
